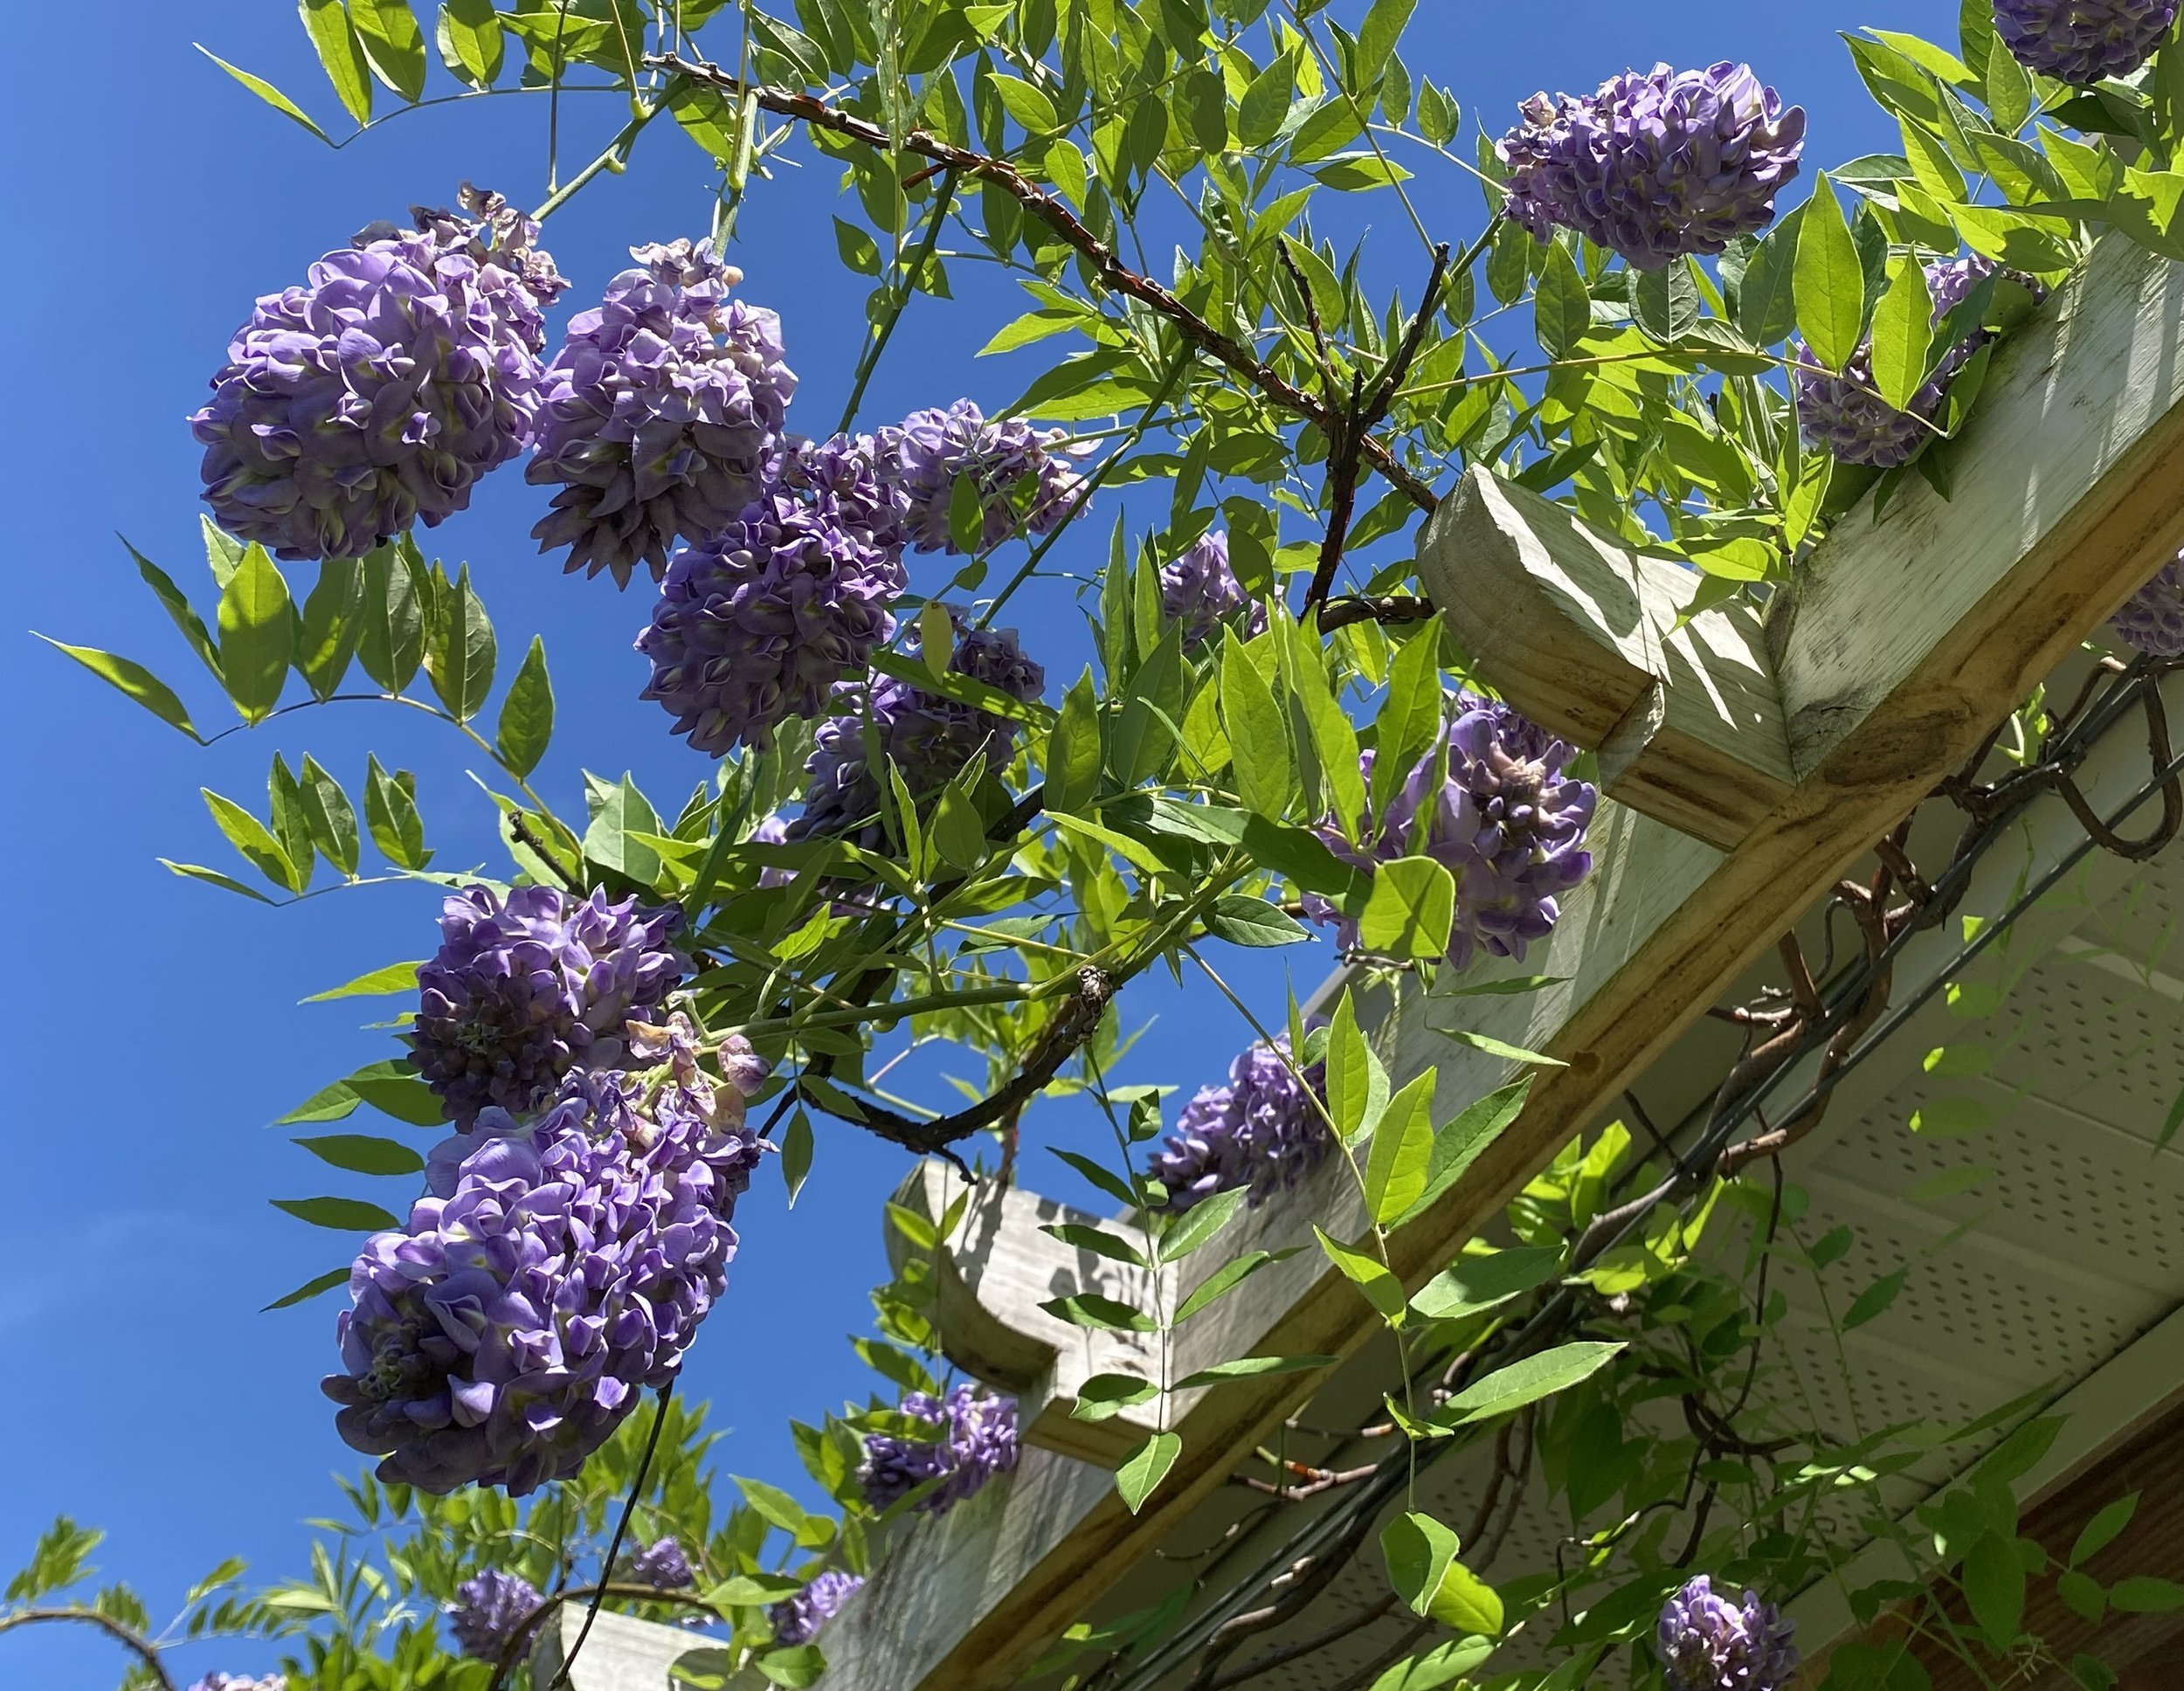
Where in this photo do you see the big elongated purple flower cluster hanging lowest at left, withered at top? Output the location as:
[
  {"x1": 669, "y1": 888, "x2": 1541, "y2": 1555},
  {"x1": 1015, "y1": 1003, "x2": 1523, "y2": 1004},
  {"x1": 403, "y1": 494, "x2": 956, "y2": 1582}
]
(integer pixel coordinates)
[{"x1": 323, "y1": 1071, "x2": 767, "y2": 1496}]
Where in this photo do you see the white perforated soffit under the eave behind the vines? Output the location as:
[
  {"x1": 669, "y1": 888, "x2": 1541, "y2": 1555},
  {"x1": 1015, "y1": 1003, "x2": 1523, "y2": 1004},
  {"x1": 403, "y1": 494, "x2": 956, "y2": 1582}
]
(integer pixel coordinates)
[{"x1": 1108, "y1": 681, "x2": 2184, "y2": 1691}]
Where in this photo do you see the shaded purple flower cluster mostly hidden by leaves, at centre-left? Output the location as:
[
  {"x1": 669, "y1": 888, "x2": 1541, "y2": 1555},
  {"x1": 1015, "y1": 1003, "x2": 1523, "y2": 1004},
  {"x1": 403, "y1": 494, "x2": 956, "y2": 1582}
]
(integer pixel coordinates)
[{"x1": 786, "y1": 618, "x2": 1047, "y2": 846}]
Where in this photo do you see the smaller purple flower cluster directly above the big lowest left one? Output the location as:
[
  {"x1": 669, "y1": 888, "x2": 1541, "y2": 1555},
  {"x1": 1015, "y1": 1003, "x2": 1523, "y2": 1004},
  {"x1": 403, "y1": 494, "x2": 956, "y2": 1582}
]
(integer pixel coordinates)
[{"x1": 409, "y1": 887, "x2": 688, "y2": 1123}]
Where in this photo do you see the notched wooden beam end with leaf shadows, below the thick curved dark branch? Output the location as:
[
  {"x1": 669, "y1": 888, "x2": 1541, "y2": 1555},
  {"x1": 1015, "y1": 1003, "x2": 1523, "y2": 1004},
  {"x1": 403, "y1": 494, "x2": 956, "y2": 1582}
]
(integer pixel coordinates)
[{"x1": 887, "y1": 1158, "x2": 1175, "y2": 1468}]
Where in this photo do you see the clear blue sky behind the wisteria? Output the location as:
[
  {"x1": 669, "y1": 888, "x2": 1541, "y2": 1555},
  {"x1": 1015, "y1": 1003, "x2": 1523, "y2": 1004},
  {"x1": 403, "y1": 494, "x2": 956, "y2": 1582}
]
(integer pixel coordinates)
[{"x1": 0, "y1": 0, "x2": 1957, "y2": 1691}]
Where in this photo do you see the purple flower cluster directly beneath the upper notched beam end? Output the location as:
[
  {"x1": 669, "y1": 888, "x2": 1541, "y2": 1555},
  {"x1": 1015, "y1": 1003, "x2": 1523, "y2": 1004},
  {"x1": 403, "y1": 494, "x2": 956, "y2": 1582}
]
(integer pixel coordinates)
[{"x1": 1304, "y1": 693, "x2": 1599, "y2": 968}]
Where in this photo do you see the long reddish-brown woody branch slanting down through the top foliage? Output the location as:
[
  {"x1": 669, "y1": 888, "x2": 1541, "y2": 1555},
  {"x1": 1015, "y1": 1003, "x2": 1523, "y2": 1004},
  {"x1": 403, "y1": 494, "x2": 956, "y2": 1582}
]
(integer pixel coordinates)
[{"x1": 645, "y1": 52, "x2": 1440, "y2": 511}]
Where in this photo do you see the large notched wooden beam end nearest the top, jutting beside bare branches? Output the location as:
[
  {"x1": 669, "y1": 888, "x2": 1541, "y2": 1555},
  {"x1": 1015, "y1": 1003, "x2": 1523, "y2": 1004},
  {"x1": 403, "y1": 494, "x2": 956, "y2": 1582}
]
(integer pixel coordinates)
[{"x1": 1418, "y1": 467, "x2": 1794, "y2": 850}]
